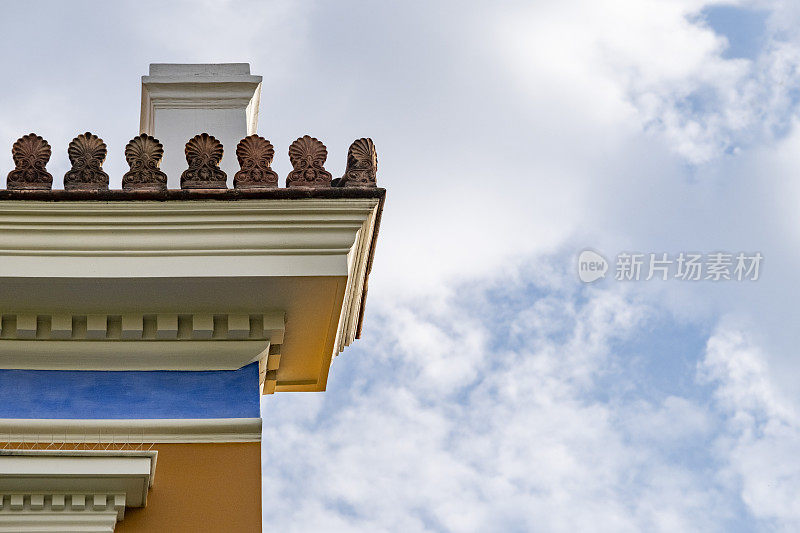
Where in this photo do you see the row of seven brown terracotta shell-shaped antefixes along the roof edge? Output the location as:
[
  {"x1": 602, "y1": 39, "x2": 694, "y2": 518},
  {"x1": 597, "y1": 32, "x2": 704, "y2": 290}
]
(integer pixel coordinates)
[{"x1": 0, "y1": 132, "x2": 385, "y2": 201}]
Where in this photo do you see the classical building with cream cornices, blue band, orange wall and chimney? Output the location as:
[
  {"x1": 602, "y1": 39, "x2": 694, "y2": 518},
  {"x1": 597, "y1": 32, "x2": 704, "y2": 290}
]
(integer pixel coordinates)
[{"x1": 0, "y1": 64, "x2": 385, "y2": 532}]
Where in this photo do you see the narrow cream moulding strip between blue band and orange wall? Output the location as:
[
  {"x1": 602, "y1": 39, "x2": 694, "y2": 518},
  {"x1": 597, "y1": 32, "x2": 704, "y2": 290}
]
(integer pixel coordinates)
[{"x1": 0, "y1": 418, "x2": 261, "y2": 444}]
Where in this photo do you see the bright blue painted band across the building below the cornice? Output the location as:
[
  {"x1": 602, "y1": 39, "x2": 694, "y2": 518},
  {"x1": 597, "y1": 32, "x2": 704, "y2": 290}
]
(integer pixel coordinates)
[{"x1": 0, "y1": 363, "x2": 259, "y2": 419}]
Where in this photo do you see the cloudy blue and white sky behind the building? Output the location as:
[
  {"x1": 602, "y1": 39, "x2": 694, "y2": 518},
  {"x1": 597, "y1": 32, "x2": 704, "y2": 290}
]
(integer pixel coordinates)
[{"x1": 0, "y1": 0, "x2": 800, "y2": 532}]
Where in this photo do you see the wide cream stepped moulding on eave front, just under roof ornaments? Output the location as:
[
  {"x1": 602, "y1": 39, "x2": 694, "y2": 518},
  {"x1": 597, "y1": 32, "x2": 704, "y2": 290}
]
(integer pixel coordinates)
[{"x1": 0, "y1": 198, "x2": 378, "y2": 278}]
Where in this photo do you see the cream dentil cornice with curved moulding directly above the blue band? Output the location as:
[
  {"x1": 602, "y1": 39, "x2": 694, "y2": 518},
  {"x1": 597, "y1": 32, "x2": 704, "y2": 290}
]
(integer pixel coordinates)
[{"x1": 0, "y1": 310, "x2": 284, "y2": 370}]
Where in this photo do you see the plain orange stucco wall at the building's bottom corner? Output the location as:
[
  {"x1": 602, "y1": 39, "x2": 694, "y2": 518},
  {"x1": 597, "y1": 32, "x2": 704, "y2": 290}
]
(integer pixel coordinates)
[{"x1": 115, "y1": 442, "x2": 261, "y2": 533}]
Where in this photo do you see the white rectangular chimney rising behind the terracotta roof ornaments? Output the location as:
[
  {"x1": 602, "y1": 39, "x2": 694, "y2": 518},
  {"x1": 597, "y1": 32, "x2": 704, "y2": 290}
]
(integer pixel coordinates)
[{"x1": 140, "y1": 63, "x2": 261, "y2": 189}]
